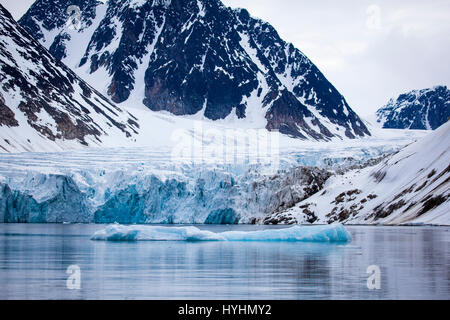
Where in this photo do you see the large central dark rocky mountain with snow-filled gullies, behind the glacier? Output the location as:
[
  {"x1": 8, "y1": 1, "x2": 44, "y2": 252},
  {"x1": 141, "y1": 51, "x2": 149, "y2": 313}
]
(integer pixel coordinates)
[{"x1": 19, "y1": 0, "x2": 370, "y2": 141}]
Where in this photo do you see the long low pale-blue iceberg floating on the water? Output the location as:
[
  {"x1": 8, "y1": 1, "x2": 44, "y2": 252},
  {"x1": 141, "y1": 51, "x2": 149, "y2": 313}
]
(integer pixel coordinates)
[{"x1": 91, "y1": 224, "x2": 352, "y2": 242}]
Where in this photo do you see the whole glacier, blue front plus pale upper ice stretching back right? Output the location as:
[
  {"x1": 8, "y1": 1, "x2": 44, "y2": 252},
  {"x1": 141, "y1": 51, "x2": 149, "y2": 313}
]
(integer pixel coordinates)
[{"x1": 0, "y1": 129, "x2": 426, "y2": 224}]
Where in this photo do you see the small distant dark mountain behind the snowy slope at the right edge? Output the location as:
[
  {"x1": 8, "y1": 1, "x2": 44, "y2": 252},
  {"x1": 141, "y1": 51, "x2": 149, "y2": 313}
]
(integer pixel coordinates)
[{"x1": 376, "y1": 86, "x2": 450, "y2": 130}]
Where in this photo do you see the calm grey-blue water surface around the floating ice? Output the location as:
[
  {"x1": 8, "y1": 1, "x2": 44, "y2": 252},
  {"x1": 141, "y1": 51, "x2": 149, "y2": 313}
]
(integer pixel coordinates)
[{"x1": 0, "y1": 224, "x2": 450, "y2": 299}]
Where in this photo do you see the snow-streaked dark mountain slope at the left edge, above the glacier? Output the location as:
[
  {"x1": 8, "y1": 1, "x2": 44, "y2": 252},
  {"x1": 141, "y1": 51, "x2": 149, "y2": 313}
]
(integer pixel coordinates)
[{"x1": 0, "y1": 5, "x2": 139, "y2": 152}]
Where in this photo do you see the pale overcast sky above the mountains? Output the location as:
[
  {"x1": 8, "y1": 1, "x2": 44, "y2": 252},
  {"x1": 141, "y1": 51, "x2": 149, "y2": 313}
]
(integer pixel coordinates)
[{"x1": 0, "y1": 0, "x2": 450, "y2": 116}]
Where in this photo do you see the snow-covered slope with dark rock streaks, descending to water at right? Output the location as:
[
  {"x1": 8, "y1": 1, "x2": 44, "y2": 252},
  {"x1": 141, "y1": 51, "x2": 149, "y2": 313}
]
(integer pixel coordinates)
[{"x1": 265, "y1": 122, "x2": 450, "y2": 225}]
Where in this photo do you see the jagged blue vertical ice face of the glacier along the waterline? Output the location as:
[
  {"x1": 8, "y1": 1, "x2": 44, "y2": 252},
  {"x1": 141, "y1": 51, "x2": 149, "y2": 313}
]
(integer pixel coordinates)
[{"x1": 0, "y1": 167, "x2": 330, "y2": 224}]
